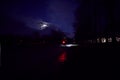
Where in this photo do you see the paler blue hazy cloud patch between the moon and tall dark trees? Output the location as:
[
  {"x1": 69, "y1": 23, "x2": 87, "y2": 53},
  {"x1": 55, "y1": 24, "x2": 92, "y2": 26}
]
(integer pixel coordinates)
[{"x1": 48, "y1": 0, "x2": 77, "y2": 36}]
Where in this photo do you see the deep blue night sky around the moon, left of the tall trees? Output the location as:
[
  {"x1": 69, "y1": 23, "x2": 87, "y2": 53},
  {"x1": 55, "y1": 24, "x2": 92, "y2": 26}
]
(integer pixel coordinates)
[{"x1": 2, "y1": 0, "x2": 78, "y2": 37}]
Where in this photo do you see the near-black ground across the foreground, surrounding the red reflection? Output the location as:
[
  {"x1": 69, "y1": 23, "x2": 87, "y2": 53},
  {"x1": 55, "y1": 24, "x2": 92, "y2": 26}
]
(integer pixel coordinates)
[{"x1": 1, "y1": 41, "x2": 120, "y2": 80}]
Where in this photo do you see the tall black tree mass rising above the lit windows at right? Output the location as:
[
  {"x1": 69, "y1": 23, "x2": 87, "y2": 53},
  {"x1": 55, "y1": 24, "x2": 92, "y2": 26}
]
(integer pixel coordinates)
[{"x1": 74, "y1": 0, "x2": 120, "y2": 40}]
